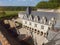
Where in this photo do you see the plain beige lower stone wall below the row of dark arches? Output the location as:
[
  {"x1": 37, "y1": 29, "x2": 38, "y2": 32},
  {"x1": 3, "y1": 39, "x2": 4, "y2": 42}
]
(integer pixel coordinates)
[{"x1": 32, "y1": 29, "x2": 48, "y2": 45}]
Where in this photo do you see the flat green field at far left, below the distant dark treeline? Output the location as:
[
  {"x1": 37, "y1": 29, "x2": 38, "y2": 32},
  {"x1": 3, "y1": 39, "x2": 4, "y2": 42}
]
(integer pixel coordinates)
[{"x1": 0, "y1": 11, "x2": 19, "y2": 18}]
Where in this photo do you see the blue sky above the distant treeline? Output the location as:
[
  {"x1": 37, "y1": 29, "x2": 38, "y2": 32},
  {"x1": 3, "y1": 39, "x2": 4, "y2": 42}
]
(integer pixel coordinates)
[{"x1": 0, "y1": 0, "x2": 41, "y2": 6}]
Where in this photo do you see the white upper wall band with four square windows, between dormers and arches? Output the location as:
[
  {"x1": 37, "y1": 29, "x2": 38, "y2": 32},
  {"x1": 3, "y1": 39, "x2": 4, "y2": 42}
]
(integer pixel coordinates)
[{"x1": 22, "y1": 19, "x2": 49, "y2": 33}]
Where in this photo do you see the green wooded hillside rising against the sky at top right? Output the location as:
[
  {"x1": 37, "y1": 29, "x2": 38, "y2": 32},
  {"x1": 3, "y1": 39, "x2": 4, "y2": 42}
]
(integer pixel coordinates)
[{"x1": 36, "y1": 0, "x2": 60, "y2": 9}]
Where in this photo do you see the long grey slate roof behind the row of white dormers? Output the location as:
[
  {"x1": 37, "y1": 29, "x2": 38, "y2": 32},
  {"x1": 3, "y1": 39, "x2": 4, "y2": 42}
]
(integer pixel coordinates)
[{"x1": 20, "y1": 11, "x2": 60, "y2": 28}]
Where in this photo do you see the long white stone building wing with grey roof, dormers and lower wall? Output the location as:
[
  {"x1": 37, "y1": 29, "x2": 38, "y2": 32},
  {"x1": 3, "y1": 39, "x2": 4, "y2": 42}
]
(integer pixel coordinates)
[{"x1": 18, "y1": 7, "x2": 60, "y2": 45}]
